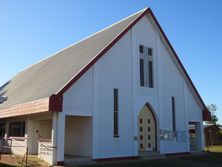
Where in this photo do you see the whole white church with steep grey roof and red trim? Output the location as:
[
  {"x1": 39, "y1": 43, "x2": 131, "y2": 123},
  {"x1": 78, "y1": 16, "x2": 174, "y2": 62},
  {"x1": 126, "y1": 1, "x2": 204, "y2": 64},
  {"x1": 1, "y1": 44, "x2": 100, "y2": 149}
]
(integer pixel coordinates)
[{"x1": 0, "y1": 8, "x2": 210, "y2": 164}]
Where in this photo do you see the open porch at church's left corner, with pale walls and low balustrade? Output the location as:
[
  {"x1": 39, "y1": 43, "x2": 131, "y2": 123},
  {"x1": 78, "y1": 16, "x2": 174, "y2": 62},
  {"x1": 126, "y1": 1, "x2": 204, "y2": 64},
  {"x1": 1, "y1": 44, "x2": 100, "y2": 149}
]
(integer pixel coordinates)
[{"x1": 0, "y1": 112, "x2": 92, "y2": 164}]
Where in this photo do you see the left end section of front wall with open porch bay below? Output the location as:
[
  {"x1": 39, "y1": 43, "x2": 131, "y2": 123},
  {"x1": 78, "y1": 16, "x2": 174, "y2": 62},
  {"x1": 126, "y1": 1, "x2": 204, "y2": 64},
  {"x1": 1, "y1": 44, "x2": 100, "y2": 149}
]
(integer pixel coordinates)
[{"x1": 61, "y1": 64, "x2": 93, "y2": 157}]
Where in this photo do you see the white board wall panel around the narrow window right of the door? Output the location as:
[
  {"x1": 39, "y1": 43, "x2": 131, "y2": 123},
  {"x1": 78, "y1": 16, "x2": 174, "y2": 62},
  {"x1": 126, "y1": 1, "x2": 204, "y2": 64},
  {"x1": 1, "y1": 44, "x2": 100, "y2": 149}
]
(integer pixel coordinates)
[{"x1": 158, "y1": 28, "x2": 189, "y2": 154}]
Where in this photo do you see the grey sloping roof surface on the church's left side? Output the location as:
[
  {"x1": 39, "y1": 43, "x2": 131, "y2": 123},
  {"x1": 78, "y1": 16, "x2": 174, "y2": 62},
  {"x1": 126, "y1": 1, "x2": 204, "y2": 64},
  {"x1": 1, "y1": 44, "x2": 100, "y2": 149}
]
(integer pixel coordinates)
[{"x1": 0, "y1": 9, "x2": 146, "y2": 109}]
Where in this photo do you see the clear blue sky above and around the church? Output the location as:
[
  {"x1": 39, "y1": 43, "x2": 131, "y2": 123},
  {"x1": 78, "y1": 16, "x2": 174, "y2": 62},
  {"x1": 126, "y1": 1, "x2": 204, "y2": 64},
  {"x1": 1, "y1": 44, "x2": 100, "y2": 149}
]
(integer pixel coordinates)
[{"x1": 0, "y1": 0, "x2": 222, "y2": 123}]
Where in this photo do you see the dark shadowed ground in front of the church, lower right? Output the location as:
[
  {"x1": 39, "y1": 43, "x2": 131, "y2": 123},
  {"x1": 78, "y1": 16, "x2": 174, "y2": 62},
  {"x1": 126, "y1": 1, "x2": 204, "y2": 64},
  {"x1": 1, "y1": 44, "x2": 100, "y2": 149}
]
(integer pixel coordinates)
[{"x1": 79, "y1": 153, "x2": 222, "y2": 167}]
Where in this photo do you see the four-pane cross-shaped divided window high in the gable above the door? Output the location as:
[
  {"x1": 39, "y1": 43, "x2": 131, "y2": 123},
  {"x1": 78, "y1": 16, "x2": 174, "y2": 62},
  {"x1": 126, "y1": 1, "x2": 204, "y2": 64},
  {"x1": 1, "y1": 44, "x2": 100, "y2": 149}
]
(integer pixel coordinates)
[{"x1": 139, "y1": 45, "x2": 153, "y2": 88}]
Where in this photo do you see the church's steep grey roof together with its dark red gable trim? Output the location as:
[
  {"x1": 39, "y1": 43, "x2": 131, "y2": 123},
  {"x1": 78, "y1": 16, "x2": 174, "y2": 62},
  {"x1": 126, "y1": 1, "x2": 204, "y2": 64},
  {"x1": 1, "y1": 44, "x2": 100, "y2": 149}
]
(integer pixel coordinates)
[{"x1": 0, "y1": 8, "x2": 210, "y2": 119}]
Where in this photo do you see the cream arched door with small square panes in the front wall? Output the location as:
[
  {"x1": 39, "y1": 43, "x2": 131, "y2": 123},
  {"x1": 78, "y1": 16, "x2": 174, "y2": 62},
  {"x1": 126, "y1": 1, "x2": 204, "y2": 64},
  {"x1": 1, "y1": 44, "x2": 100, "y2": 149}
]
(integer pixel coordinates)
[{"x1": 138, "y1": 104, "x2": 157, "y2": 152}]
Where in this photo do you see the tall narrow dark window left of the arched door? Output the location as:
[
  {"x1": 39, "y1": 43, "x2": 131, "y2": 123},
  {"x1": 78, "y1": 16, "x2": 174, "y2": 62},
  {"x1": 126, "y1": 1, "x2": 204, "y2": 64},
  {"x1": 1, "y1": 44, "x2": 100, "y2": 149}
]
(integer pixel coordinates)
[{"x1": 113, "y1": 89, "x2": 119, "y2": 137}]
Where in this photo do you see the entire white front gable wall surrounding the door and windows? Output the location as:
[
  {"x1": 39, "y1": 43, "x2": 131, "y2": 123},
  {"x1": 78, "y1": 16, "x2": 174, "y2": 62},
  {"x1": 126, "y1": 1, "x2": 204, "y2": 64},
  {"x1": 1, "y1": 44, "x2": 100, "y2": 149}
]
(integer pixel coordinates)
[{"x1": 63, "y1": 13, "x2": 205, "y2": 159}]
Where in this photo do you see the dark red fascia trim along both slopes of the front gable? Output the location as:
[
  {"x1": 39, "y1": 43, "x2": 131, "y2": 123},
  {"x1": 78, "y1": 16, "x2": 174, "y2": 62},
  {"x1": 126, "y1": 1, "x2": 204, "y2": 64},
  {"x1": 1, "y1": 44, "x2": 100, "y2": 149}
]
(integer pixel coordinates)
[{"x1": 50, "y1": 8, "x2": 208, "y2": 117}]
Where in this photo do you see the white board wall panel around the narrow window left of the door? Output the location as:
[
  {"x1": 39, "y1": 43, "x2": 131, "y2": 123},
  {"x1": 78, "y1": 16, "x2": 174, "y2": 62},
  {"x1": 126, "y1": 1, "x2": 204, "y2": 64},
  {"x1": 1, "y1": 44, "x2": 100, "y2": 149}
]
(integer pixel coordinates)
[{"x1": 93, "y1": 31, "x2": 133, "y2": 159}]
